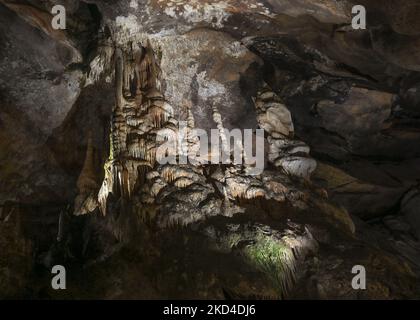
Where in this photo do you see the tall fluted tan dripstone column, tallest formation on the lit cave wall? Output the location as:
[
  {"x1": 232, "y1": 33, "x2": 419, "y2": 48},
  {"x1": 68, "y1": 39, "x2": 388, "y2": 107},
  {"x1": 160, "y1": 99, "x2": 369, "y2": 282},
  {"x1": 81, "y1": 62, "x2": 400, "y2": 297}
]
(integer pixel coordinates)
[{"x1": 98, "y1": 39, "x2": 176, "y2": 218}]
